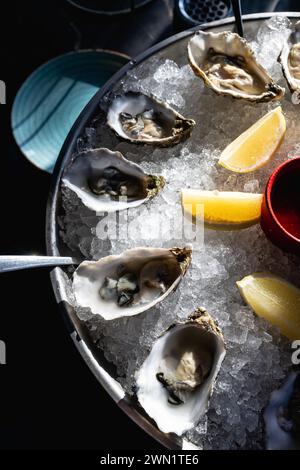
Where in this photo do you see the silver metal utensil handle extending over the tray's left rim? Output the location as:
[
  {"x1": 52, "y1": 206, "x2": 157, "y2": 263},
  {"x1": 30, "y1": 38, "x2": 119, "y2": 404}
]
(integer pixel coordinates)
[{"x1": 0, "y1": 255, "x2": 78, "y2": 273}]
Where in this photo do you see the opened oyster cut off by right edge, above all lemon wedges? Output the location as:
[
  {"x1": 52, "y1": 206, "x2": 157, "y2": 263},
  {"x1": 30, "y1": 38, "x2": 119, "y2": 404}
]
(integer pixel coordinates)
[{"x1": 278, "y1": 21, "x2": 300, "y2": 98}]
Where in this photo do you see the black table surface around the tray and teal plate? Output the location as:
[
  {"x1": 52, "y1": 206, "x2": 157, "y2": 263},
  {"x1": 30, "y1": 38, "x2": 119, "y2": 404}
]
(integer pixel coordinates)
[{"x1": 0, "y1": 0, "x2": 293, "y2": 450}]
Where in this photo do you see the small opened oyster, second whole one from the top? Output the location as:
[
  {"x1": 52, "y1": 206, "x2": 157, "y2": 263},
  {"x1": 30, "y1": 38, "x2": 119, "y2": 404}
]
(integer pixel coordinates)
[{"x1": 107, "y1": 92, "x2": 195, "y2": 145}]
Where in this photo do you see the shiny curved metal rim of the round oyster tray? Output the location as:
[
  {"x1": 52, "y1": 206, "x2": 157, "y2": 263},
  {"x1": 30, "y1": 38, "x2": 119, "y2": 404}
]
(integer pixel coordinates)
[{"x1": 46, "y1": 12, "x2": 300, "y2": 450}]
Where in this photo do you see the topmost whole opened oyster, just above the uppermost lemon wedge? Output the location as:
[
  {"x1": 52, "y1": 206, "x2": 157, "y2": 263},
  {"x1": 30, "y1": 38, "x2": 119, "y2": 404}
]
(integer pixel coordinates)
[{"x1": 188, "y1": 31, "x2": 284, "y2": 102}]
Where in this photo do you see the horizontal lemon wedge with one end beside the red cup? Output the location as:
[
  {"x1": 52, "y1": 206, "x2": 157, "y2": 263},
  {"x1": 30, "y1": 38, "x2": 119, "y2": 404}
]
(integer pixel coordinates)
[{"x1": 181, "y1": 189, "x2": 263, "y2": 229}]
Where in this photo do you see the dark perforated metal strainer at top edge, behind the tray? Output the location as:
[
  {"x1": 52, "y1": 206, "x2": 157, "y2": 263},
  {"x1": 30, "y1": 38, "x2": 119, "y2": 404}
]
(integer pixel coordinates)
[{"x1": 175, "y1": 0, "x2": 231, "y2": 28}]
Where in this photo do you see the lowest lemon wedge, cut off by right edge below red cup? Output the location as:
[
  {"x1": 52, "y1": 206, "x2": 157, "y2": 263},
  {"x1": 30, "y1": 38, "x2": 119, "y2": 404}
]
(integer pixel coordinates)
[{"x1": 237, "y1": 273, "x2": 300, "y2": 340}]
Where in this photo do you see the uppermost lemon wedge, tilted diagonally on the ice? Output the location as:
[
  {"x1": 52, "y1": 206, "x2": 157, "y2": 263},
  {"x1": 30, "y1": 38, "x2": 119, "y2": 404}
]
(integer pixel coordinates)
[{"x1": 219, "y1": 106, "x2": 286, "y2": 173}]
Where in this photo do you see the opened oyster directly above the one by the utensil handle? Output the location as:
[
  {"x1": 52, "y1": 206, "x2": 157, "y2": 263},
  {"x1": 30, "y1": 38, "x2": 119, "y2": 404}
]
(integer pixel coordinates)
[{"x1": 62, "y1": 148, "x2": 165, "y2": 212}]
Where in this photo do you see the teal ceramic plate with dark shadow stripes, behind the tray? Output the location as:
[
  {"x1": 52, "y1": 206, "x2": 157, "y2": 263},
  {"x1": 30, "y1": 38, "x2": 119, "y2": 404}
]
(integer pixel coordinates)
[{"x1": 12, "y1": 50, "x2": 129, "y2": 173}]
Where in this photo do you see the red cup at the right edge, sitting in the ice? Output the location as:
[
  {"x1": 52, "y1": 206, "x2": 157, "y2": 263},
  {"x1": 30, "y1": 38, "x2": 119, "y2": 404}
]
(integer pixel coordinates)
[{"x1": 260, "y1": 157, "x2": 300, "y2": 255}]
